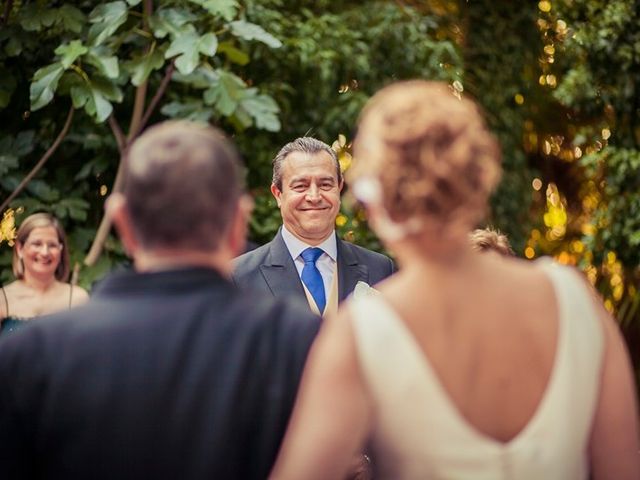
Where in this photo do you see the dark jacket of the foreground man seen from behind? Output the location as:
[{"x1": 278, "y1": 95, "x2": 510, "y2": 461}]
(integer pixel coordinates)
[{"x1": 0, "y1": 268, "x2": 319, "y2": 480}]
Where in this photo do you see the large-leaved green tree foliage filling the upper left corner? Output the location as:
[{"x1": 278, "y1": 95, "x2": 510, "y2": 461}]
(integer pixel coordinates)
[{"x1": 0, "y1": 0, "x2": 280, "y2": 286}]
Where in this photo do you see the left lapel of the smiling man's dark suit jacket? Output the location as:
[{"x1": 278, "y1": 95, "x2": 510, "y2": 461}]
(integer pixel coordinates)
[{"x1": 260, "y1": 231, "x2": 306, "y2": 300}]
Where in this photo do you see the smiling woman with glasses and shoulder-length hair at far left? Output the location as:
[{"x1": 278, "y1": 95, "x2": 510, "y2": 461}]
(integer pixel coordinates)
[{"x1": 0, "y1": 213, "x2": 88, "y2": 334}]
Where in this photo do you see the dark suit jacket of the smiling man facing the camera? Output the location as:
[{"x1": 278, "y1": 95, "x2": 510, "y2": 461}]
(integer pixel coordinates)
[{"x1": 232, "y1": 230, "x2": 395, "y2": 304}]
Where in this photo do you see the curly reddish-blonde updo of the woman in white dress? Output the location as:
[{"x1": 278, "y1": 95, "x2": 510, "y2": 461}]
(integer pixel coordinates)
[{"x1": 349, "y1": 80, "x2": 500, "y2": 229}]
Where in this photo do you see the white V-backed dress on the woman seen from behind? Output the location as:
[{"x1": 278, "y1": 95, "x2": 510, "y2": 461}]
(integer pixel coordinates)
[{"x1": 349, "y1": 260, "x2": 603, "y2": 480}]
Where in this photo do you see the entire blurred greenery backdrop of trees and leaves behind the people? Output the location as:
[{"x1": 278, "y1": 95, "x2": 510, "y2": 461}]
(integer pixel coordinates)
[{"x1": 0, "y1": 0, "x2": 640, "y2": 376}]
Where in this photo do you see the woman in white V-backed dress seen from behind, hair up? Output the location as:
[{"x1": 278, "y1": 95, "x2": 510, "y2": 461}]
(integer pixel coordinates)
[{"x1": 272, "y1": 81, "x2": 640, "y2": 480}]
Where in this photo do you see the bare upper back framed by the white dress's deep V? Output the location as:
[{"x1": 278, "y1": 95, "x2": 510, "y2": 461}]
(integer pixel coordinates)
[{"x1": 385, "y1": 254, "x2": 559, "y2": 442}]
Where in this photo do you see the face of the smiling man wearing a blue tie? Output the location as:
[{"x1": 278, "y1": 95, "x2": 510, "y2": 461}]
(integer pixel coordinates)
[{"x1": 271, "y1": 152, "x2": 342, "y2": 245}]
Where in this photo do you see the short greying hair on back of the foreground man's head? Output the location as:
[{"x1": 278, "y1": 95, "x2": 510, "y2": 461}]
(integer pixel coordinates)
[{"x1": 123, "y1": 121, "x2": 243, "y2": 251}]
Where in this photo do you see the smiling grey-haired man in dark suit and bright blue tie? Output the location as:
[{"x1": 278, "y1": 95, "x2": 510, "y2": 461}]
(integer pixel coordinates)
[{"x1": 233, "y1": 137, "x2": 394, "y2": 315}]
